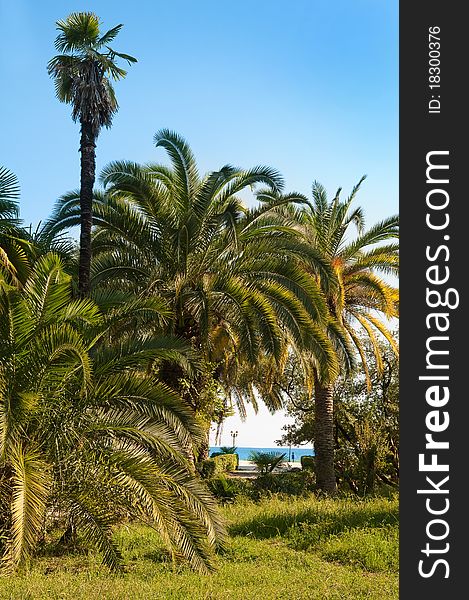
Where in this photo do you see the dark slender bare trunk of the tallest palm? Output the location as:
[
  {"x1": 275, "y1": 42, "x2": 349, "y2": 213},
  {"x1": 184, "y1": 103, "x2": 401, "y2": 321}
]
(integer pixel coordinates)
[{"x1": 78, "y1": 121, "x2": 96, "y2": 297}]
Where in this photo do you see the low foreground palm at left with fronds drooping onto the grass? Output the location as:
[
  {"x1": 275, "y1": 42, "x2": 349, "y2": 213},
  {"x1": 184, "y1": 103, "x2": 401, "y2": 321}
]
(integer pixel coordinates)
[{"x1": 0, "y1": 254, "x2": 224, "y2": 570}]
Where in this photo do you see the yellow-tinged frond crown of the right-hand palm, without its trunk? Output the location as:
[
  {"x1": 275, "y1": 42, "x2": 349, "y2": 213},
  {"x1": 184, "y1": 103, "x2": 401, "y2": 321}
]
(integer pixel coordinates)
[{"x1": 302, "y1": 177, "x2": 399, "y2": 374}]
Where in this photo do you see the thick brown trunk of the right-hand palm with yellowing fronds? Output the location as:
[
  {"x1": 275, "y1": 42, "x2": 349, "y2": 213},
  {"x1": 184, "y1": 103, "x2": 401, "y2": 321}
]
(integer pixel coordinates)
[{"x1": 314, "y1": 376, "x2": 337, "y2": 496}]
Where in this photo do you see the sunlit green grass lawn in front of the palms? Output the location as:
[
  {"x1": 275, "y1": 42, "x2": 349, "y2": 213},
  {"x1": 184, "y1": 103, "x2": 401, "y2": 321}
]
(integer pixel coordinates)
[{"x1": 0, "y1": 497, "x2": 398, "y2": 600}]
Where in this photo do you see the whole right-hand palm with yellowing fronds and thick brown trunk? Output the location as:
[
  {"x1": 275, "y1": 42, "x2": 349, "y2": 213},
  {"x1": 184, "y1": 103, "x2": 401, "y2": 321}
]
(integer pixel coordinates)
[{"x1": 284, "y1": 177, "x2": 399, "y2": 494}]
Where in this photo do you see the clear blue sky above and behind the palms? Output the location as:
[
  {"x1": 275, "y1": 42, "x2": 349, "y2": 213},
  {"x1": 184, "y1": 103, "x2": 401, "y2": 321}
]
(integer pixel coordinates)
[{"x1": 0, "y1": 0, "x2": 398, "y2": 446}]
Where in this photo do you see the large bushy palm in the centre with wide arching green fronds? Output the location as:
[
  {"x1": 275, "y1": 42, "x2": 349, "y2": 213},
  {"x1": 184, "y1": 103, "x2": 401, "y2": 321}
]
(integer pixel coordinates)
[{"x1": 44, "y1": 130, "x2": 335, "y2": 460}]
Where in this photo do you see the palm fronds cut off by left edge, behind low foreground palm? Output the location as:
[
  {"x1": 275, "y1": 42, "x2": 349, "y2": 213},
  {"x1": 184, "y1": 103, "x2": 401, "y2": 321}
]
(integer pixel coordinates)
[{"x1": 0, "y1": 166, "x2": 29, "y2": 285}]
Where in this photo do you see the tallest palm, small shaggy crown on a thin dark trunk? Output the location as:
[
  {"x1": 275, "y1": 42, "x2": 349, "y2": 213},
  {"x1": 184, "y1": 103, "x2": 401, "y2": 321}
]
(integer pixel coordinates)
[{"x1": 47, "y1": 12, "x2": 136, "y2": 296}]
